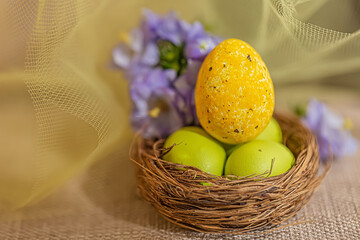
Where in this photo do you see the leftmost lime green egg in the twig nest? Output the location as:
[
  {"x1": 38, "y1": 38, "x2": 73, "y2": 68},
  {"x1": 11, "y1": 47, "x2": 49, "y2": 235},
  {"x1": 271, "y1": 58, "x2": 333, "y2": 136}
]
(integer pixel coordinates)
[{"x1": 164, "y1": 127, "x2": 226, "y2": 176}]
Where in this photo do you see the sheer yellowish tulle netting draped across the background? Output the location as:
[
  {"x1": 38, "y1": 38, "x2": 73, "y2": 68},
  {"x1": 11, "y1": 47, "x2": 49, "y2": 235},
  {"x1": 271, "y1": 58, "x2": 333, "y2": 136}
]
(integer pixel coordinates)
[{"x1": 0, "y1": 0, "x2": 360, "y2": 211}]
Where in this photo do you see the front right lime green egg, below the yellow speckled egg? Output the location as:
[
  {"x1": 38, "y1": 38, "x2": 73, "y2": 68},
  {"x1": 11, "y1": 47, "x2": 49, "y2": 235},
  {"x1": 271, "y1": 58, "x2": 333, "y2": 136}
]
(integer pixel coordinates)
[{"x1": 225, "y1": 140, "x2": 295, "y2": 177}]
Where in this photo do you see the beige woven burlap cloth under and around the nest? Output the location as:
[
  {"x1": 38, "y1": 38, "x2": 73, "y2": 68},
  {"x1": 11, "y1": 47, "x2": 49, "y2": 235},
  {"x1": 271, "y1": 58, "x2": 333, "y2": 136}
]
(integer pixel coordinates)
[{"x1": 0, "y1": 87, "x2": 360, "y2": 240}]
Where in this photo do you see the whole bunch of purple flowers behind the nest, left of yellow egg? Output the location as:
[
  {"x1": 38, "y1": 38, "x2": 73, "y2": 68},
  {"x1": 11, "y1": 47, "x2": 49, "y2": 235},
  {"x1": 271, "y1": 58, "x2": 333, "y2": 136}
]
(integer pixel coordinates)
[{"x1": 113, "y1": 10, "x2": 220, "y2": 138}]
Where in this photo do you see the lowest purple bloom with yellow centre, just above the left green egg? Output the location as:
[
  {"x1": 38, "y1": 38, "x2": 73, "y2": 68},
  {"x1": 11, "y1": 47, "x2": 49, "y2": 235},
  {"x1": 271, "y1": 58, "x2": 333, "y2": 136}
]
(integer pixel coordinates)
[{"x1": 130, "y1": 68, "x2": 185, "y2": 138}]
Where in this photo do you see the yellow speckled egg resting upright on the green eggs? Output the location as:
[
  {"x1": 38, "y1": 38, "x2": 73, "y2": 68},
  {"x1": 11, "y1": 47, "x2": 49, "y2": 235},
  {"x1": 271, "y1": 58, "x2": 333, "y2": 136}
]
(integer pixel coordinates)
[{"x1": 195, "y1": 39, "x2": 275, "y2": 144}]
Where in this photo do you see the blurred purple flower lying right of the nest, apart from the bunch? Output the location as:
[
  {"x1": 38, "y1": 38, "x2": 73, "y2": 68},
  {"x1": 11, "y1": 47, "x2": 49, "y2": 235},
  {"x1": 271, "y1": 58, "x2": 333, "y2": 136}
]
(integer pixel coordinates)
[{"x1": 303, "y1": 99, "x2": 358, "y2": 159}]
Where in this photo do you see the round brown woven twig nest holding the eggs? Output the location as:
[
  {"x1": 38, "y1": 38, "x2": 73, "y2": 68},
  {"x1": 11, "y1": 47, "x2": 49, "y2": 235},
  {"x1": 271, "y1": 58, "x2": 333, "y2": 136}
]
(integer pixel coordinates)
[{"x1": 130, "y1": 114, "x2": 330, "y2": 234}]
